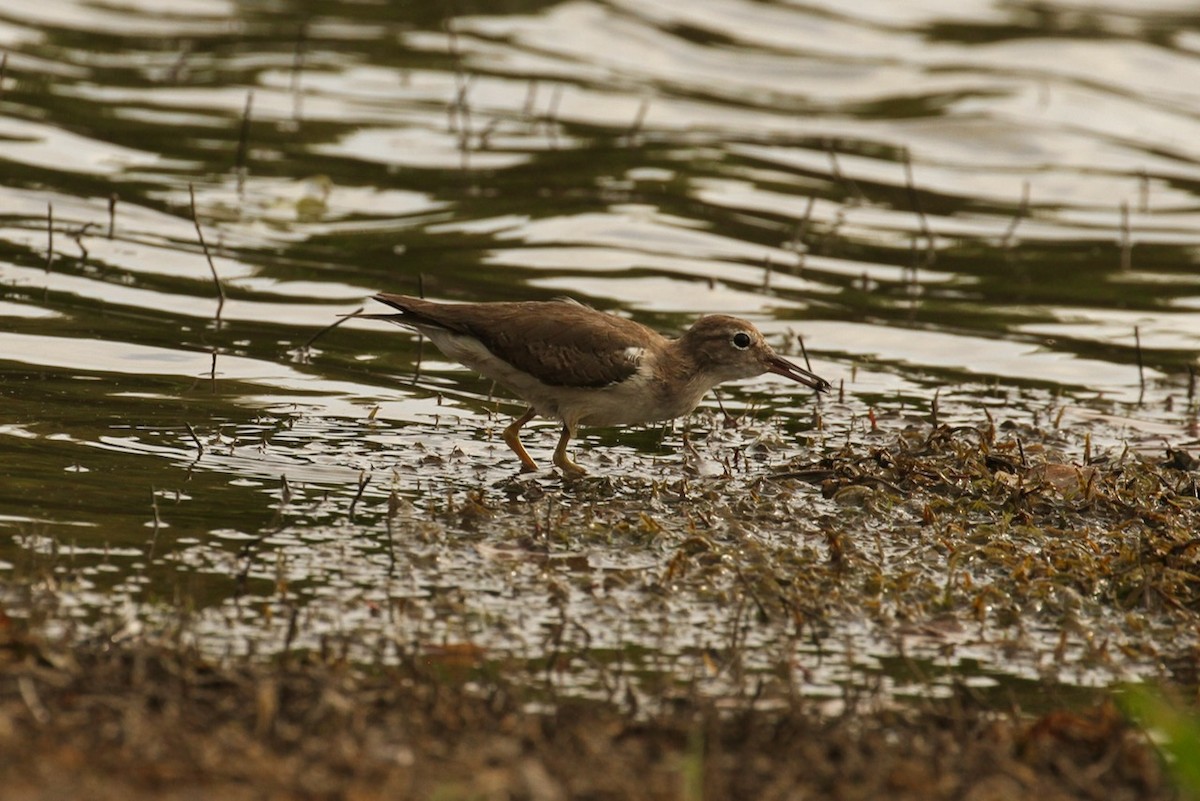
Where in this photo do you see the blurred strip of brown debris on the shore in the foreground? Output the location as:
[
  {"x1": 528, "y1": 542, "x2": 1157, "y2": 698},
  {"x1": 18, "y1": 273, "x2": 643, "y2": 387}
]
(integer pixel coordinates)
[{"x1": 0, "y1": 622, "x2": 1175, "y2": 801}]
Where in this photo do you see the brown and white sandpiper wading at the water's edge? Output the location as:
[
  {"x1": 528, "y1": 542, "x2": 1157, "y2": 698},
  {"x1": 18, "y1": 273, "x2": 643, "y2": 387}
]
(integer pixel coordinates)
[{"x1": 362, "y1": 293, "x2": 829, "y2": 476}]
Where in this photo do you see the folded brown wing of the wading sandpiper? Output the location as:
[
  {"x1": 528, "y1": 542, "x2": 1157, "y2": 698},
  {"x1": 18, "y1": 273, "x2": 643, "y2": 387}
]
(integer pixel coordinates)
[{"x1": 373, "y1": 294, "x2": 661, "y2": 387}]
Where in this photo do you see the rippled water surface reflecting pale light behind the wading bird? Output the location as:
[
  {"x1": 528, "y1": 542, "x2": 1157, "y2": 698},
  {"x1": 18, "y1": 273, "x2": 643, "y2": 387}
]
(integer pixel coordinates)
[{"x1": 0, "y1": 0, "x2": 1200, "y2": 692}]
